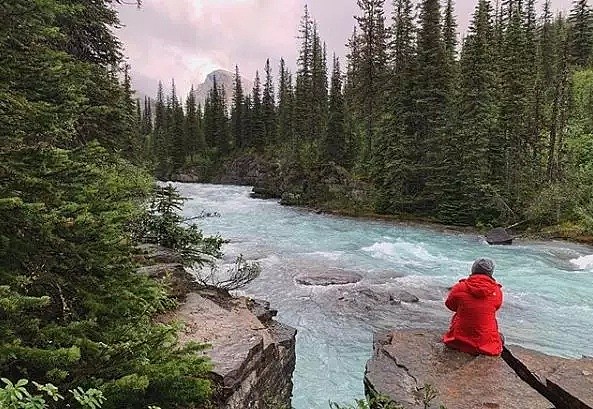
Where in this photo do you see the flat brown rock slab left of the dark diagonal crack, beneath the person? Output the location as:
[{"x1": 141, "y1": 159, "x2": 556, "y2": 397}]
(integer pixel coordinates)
[{"x1": 365, "y1": 330, "x2": 552, "y2": 409}]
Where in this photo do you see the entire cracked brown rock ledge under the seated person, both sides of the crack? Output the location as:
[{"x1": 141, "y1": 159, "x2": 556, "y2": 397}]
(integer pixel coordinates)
[{"x1": 364, "y1": 330, "x2": 593, "y2": 409}]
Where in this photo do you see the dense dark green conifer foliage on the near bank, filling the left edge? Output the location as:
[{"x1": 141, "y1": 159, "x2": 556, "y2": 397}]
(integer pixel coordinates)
[{"x1": 0, "y1": 0, "x2": 210, "y2": 408}]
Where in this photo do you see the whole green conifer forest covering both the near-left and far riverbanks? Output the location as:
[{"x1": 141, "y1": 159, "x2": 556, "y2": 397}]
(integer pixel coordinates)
[{"x1": 0, "y1": 0, "x2": 593, "y2": 409}]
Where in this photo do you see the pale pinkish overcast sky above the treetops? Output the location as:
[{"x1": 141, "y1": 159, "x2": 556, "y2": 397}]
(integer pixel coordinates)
[{"x1": 118, "y1": 0, "x2": 571, "y2": 95}]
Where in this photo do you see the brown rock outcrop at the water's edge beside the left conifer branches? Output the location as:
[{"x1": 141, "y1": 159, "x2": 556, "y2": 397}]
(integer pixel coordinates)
[{"x1": 136, "y1": 245, "x2": 296, "y2": 409}]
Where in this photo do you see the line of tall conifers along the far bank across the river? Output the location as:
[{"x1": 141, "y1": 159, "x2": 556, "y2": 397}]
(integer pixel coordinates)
[{"x1": 139, "y1": 0, "x2": 593, "y2": 230}]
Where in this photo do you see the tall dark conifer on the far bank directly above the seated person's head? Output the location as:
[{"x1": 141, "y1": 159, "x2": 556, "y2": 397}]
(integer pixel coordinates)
[{"x1": 448, "y1": 0, "x2": 499, "y2": 225}]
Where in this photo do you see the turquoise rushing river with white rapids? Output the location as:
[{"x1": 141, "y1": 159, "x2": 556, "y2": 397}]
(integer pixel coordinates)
[{"x1": 177, "y1": 184, "x2": 593, "y2": 409}]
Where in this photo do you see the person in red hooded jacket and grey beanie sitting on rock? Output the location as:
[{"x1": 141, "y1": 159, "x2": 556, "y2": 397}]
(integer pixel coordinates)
[{"x1": 443, "y1": 258, "x2": 503, "y2": 356}]
